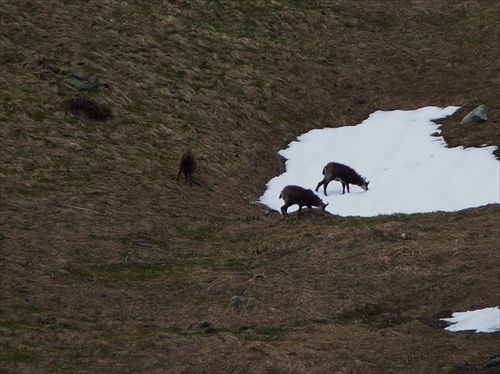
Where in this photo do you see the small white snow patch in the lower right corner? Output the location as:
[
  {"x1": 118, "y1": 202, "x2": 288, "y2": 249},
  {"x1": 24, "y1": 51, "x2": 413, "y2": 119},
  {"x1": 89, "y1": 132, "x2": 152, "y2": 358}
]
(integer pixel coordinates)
[{"x1": 441, "y1": 307, "x2": 500, "y2": 333}]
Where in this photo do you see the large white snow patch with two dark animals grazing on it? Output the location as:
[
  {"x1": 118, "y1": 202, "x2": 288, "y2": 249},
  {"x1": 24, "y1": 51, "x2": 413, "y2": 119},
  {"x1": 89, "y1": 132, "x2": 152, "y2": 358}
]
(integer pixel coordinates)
[{"x1": 259, "y1": 106, "x2": 500, "y2": 217}]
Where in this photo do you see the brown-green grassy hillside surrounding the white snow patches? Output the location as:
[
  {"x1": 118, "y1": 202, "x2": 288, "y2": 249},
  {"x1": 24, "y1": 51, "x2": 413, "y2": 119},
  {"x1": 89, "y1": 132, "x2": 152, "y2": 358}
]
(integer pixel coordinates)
[{"x1": 0, "y1": 0, "x2": 500, "y2": 373}]
